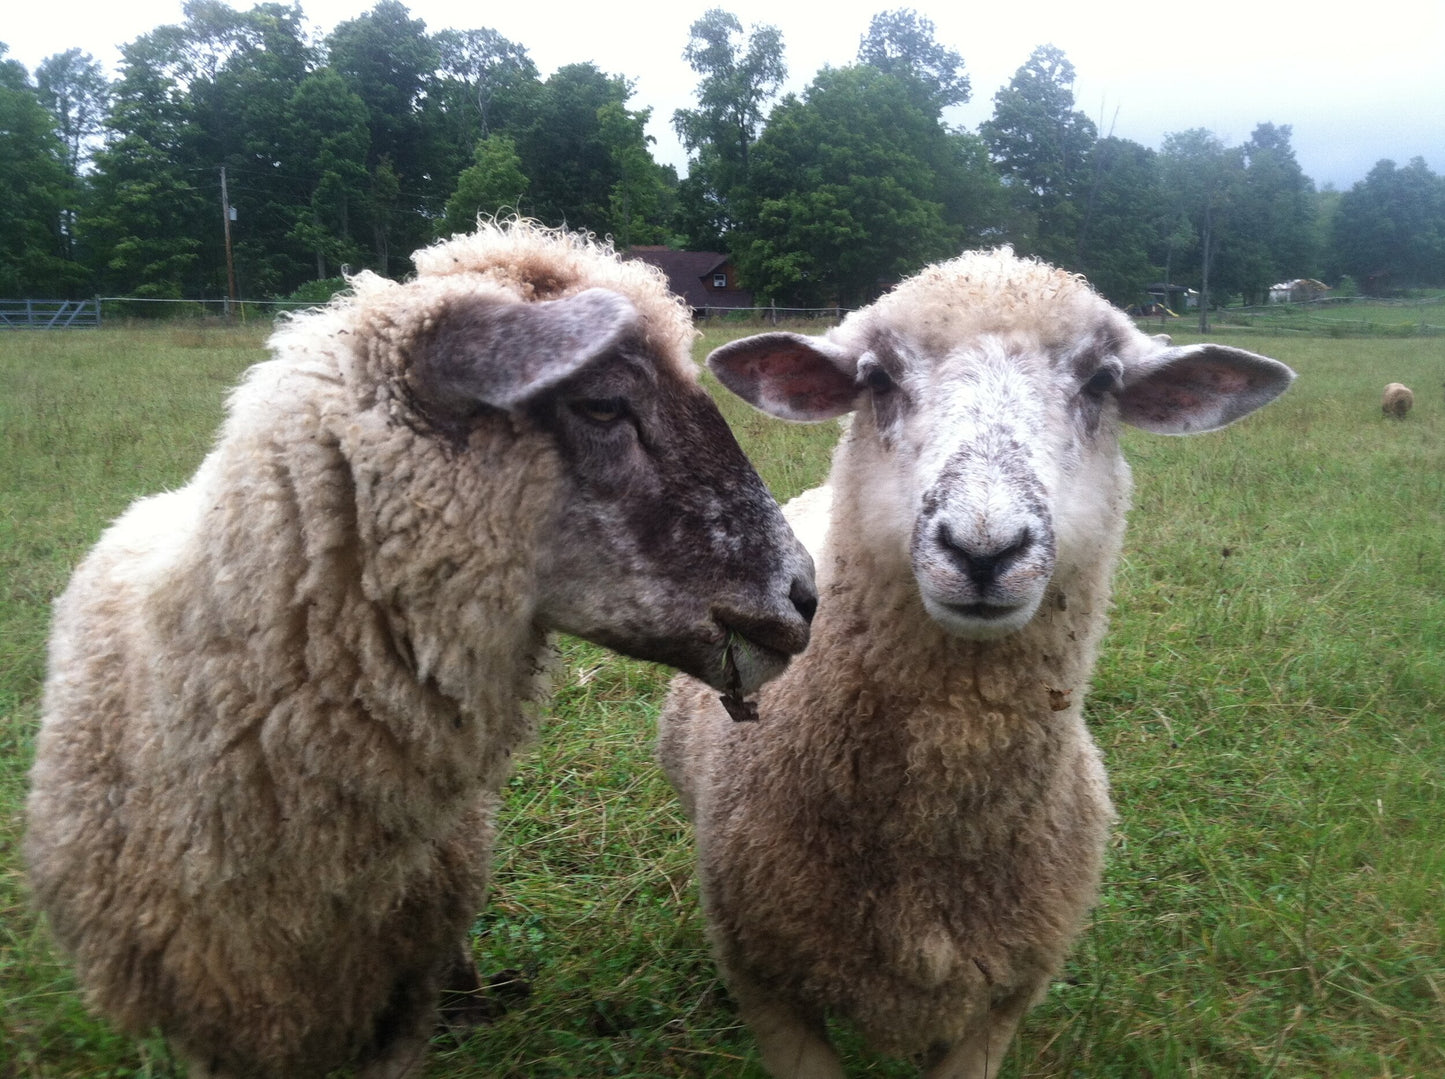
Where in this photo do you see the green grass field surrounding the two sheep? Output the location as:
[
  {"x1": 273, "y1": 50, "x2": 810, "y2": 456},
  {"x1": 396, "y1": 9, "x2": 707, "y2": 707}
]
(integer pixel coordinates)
[{"x1": 0, "y1": 319, "x2": 1445, "y2": 1079}]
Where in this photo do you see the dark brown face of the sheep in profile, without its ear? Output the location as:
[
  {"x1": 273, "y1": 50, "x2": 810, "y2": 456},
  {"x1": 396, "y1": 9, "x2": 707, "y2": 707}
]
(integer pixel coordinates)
[{"x1": 529, "y1": 342, "x2": 815, "y2": 692}]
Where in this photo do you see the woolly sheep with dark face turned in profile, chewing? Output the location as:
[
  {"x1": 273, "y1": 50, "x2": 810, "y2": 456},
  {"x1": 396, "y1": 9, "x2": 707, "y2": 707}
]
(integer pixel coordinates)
[{"x1": 26, "y1": 221, "x2": 815, "y2": 1079}]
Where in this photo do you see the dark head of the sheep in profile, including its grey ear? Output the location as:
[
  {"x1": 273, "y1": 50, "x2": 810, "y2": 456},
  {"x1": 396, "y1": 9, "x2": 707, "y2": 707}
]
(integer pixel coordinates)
[{"x1": 374, "y1": 276, "x2": 816, "y2": 695}]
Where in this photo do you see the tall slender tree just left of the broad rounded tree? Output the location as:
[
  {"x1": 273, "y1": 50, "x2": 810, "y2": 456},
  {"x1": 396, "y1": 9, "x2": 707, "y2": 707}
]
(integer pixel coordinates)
[{"x1": 672, "y1": 7, "x2": 788, "y2": 248}]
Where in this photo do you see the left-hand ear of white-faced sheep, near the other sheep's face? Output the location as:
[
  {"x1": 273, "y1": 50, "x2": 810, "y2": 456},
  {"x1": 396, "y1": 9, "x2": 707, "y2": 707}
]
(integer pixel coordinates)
[{"x1": 708, "y1": 332, "x2": 858, "y2": 423}]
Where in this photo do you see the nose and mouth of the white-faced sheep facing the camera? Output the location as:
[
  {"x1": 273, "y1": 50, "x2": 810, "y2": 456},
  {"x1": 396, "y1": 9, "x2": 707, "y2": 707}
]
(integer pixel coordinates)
[{"x1": 912, "y1": 510, "x2": 1055, "y2": 638}]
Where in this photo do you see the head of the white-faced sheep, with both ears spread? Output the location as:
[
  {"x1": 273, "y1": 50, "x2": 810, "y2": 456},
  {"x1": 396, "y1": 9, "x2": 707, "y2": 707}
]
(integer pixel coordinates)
[{"x1": 708, "y1": 253, "x2": 1293, "y2": 638}]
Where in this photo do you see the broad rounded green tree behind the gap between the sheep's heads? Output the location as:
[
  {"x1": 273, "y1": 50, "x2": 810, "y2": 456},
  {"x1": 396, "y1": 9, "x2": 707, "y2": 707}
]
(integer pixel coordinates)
[{"x1": 736, "y1": 65, "x2": 991, "y2": 306}]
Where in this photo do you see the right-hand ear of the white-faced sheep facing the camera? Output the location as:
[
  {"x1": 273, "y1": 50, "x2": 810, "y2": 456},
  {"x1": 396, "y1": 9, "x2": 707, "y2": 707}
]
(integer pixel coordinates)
[{"x1": 1118, "y1": 345, "x2": 1295, "y2": 435}]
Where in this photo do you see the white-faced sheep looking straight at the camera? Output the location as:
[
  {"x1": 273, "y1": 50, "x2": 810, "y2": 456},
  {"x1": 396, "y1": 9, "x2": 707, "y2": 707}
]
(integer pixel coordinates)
[{"x1": 657, "y1": 248, "x2": 1293, "y2": 1079}]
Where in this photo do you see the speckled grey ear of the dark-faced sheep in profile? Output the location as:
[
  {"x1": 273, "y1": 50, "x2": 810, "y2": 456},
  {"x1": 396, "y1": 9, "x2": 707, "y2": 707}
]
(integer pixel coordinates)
[{"x1": 407, "y1": 289, "x2": 639, "y2": 413}]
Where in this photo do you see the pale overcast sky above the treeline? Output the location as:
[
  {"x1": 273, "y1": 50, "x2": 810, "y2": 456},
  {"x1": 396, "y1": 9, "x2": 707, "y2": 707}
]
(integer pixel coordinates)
[{"x1": 0, "y1": 0, "x2": 1445, "y2": 189}]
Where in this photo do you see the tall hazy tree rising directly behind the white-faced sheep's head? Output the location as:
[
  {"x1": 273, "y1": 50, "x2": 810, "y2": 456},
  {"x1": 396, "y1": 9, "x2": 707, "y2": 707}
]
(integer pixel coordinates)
[{"x1": 978, "y1": 45, "x2": 1097, "y2": 264}]
